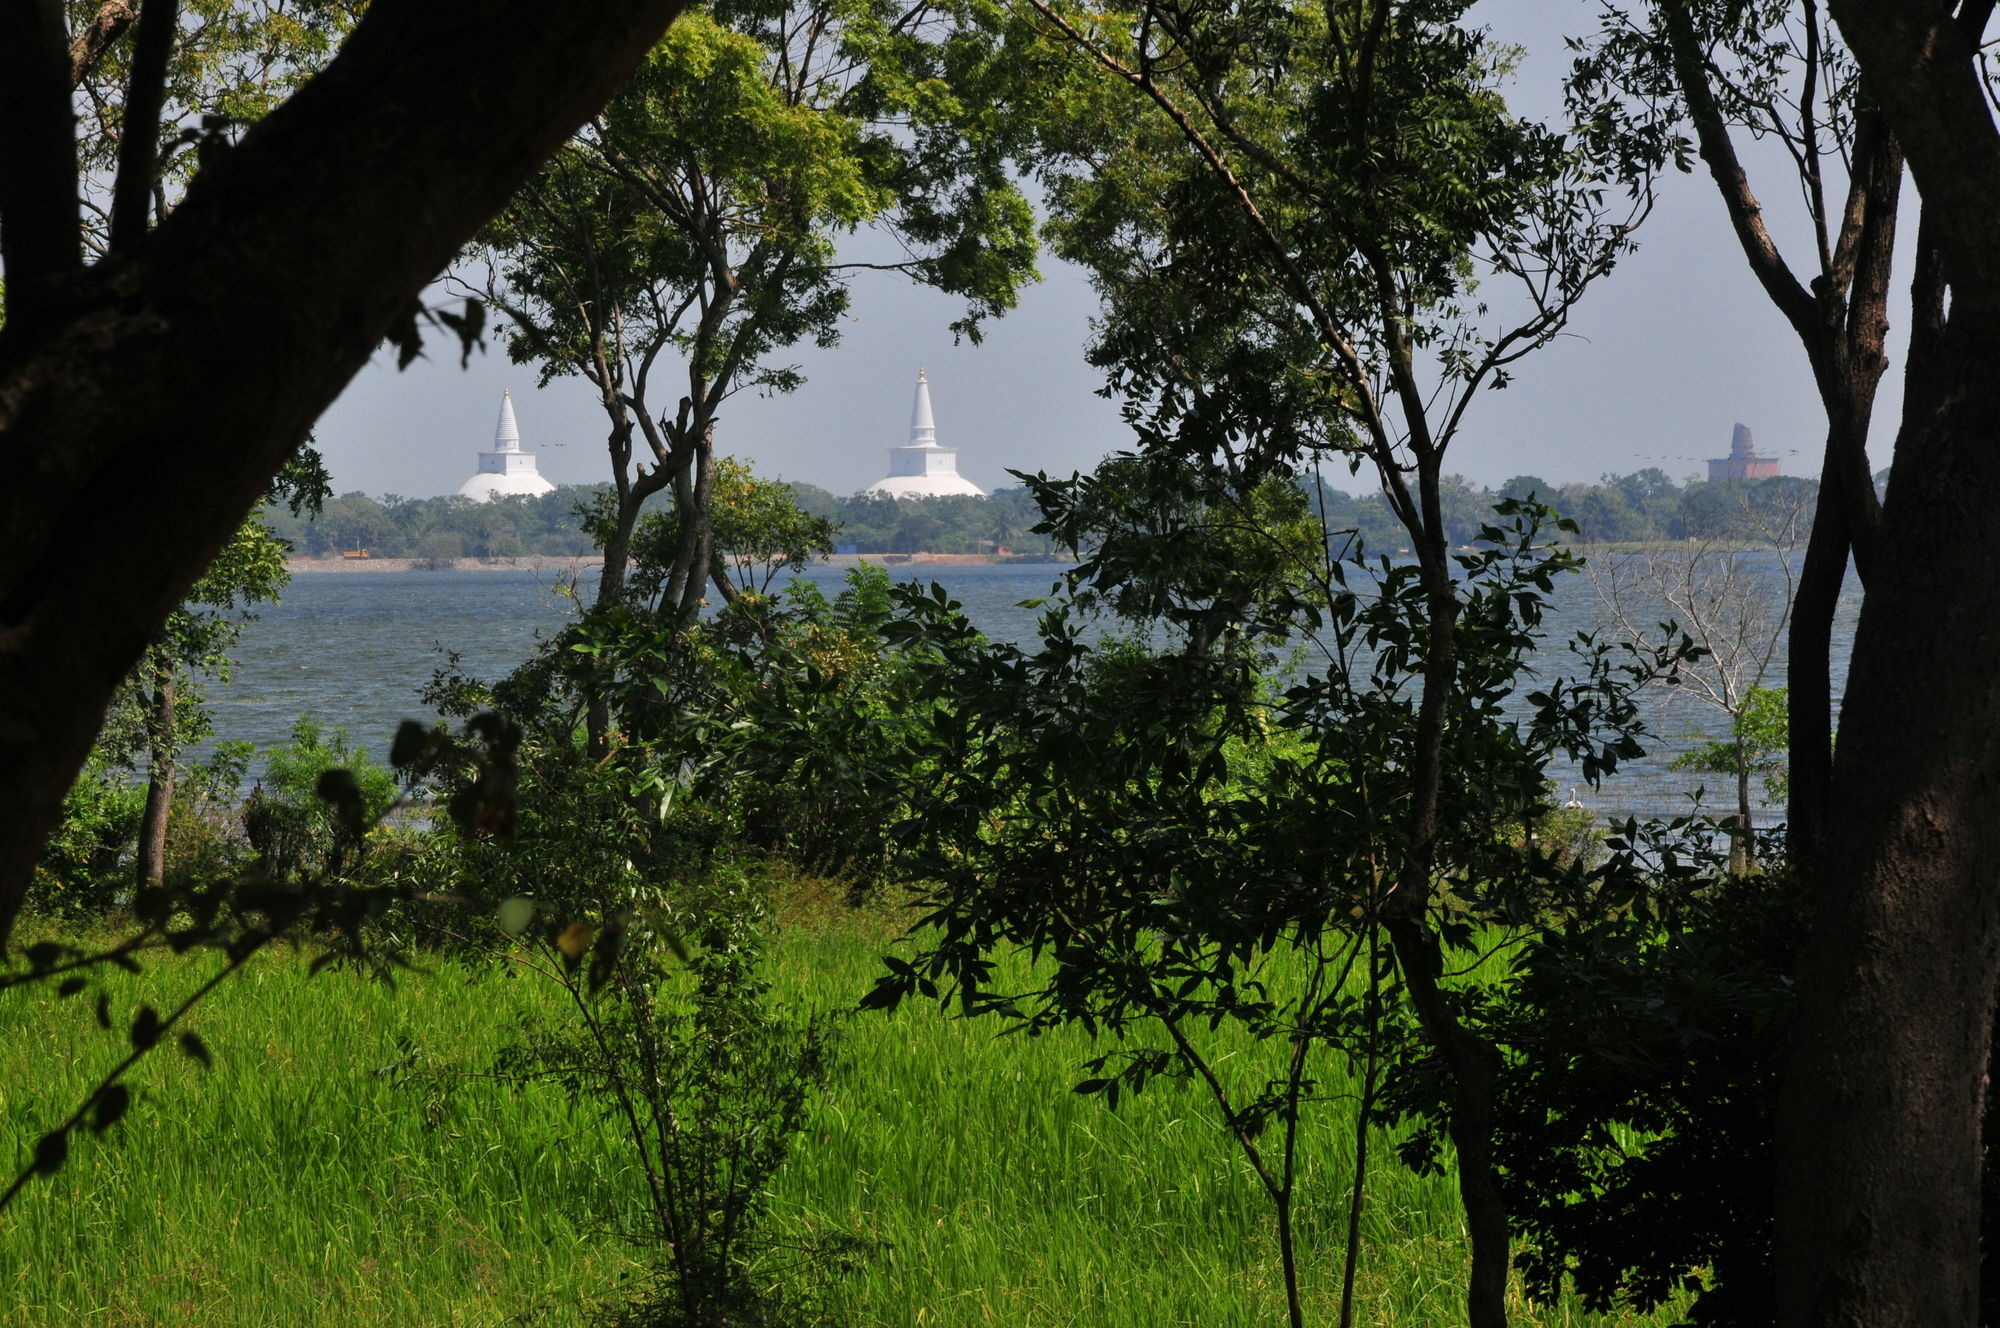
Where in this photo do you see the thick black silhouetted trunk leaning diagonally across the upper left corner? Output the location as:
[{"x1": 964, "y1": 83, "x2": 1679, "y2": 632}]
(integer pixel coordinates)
[{"x1": 0, "y1": 0, "x2": 682, "y2": 938}]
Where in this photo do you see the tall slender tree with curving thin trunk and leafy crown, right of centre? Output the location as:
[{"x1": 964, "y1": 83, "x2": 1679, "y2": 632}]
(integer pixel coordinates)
[{"x1": 1012, "y1": 0, "x2": 1648, "y2": 1328}]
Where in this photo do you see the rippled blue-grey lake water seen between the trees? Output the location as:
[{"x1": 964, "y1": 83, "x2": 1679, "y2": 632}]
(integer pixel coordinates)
[{"x1": 212, "y1": 554, "x2": 1858, "y2": 816}]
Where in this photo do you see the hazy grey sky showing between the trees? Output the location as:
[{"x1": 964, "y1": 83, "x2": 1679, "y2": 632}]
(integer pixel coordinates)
[{"x1": 316, "y1": 0, "x2": 1888, "y2": 496}]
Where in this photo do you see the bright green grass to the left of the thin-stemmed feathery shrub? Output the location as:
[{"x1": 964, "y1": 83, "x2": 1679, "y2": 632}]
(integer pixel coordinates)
[{"x1": 0, "y1": 956, "x2": 630, "y2": 1328}]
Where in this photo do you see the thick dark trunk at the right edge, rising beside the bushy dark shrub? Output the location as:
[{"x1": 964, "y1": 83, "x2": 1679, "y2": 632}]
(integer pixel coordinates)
[{"x1": 1778, "y1": 304, "x2": 2000, "y2": 1328}]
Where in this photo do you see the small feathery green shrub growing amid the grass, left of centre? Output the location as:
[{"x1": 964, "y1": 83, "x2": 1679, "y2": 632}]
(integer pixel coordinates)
[{"x1": 498, "y1": 872, "x2": 856, "y2": 1328}]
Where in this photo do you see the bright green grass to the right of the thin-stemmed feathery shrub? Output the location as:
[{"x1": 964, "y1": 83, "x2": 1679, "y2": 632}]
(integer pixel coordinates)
[{"x1": 756, "y1": 928, "x2": 1672, "y2": 1328}]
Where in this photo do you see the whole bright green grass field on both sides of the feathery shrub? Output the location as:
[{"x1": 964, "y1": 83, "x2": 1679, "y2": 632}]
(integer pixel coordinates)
[{"x1": 0, "y1": 922, "x2": 1672, "y2": 1328}]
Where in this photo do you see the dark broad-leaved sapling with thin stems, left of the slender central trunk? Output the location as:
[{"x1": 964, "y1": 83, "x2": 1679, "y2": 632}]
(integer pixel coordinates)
[{"x1": 864, "y1": 472, "x2": 1680, "y2": 1328}]
